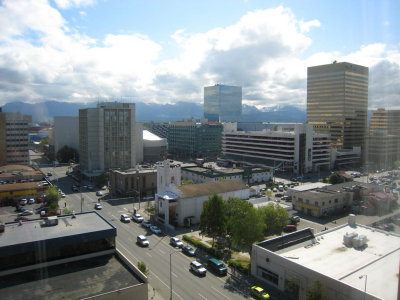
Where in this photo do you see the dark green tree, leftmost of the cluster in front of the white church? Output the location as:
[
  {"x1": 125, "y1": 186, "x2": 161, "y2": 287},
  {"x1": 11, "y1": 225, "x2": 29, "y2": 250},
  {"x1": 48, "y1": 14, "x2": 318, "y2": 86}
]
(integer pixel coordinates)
[{"x1": 199, "y1": 194, "x2": 226, "y2": 247}]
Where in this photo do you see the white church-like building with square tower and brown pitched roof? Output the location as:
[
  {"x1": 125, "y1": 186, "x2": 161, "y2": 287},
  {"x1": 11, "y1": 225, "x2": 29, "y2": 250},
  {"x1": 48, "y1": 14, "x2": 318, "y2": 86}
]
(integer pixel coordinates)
[{"x1": 155, "y1": 161, "x2": 249, "y2": 227}]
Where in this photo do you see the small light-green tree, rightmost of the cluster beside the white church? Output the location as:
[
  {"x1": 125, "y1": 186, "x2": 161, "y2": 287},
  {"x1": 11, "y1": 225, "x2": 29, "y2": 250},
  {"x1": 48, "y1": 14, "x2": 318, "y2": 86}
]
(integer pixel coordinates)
[{"x1": 258, "y1": 204, "x2": 289, "y2": 235}]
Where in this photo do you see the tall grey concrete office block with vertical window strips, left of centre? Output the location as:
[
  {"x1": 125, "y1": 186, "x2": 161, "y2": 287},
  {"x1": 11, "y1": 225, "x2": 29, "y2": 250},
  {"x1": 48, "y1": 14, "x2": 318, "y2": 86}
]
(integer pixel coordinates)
[{"x1": 79, "y1": 102, "x2": 136, "y2": 175}]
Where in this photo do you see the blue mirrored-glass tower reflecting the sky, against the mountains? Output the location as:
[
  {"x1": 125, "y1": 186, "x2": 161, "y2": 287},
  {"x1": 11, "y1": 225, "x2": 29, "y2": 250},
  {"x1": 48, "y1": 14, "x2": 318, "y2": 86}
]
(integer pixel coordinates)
[{"x1": 204, "y1": 84, "x2": 242, "y2": 122}]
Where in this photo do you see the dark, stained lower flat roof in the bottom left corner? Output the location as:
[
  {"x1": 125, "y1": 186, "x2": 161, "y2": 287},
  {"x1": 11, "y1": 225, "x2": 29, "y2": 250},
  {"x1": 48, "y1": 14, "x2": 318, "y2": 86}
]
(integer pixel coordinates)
[{"x1": 0, "y1": 254, "x2": 143, "y2": 300}]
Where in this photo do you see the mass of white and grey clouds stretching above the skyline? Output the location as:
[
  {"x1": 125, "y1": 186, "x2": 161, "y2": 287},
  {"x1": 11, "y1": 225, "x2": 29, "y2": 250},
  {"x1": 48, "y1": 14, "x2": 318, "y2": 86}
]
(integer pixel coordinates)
[{"x1": 0, "y1": 0, "x2": 400, "y2": 108}]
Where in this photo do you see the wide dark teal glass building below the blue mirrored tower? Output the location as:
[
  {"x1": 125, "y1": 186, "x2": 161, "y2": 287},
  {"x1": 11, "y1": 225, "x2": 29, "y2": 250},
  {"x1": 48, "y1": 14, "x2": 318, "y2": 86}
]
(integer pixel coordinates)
[{"x1": 168, "y1": 122, "x2": 223, "y2": 159}]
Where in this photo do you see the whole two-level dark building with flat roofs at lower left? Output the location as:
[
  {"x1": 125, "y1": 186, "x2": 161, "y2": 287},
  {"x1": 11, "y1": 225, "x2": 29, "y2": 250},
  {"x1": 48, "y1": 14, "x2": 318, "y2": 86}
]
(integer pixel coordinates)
[{"x1": 0, "y1": 212, "x2": 148, "y2": 300}]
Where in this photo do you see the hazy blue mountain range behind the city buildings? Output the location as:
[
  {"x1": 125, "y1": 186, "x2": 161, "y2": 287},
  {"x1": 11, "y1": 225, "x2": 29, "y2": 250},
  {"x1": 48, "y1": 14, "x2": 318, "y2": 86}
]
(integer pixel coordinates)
[{"x1": 2, "y1": 101, "x2": 306, "y2": 123}]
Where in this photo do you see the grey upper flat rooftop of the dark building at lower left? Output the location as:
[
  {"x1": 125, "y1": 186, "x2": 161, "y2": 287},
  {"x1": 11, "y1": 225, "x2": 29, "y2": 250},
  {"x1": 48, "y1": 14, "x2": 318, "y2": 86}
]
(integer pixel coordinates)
[{"x1": 0, "y1": 211, "x2": 116, "y2": 254}]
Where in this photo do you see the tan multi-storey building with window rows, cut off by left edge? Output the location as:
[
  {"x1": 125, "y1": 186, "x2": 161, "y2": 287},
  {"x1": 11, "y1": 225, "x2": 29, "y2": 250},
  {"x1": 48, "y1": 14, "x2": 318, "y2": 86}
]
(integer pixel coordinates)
[{"x1": 0, "y1": 111, "x2": 32, "y2": 166}]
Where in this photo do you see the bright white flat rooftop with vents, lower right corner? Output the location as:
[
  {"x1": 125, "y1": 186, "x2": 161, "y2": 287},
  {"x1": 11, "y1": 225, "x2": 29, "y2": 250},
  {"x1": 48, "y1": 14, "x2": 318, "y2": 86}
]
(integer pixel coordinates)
[{"x1": 275, "y1": 225, "x2": 400, "y2": 299}]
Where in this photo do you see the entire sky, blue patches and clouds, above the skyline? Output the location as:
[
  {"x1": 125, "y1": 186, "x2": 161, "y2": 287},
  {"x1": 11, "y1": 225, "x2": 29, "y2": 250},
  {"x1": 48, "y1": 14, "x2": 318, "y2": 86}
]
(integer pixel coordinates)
[{"x1": 0, "y1": 0, "x2": 400, "y2": 109}]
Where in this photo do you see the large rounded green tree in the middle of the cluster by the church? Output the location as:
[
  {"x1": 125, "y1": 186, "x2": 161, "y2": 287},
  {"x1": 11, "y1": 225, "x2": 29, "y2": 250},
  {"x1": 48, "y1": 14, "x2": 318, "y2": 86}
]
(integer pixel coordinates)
[{"x1": 227, "y1": 198, "x2": 264, "y2": 254}]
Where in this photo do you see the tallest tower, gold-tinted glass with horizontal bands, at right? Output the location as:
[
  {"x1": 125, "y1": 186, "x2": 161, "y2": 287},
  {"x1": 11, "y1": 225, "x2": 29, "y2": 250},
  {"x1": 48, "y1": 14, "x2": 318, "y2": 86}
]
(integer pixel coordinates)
[{"x1": 307, "y1": 62, "x2": 368, "y2": 151}]
